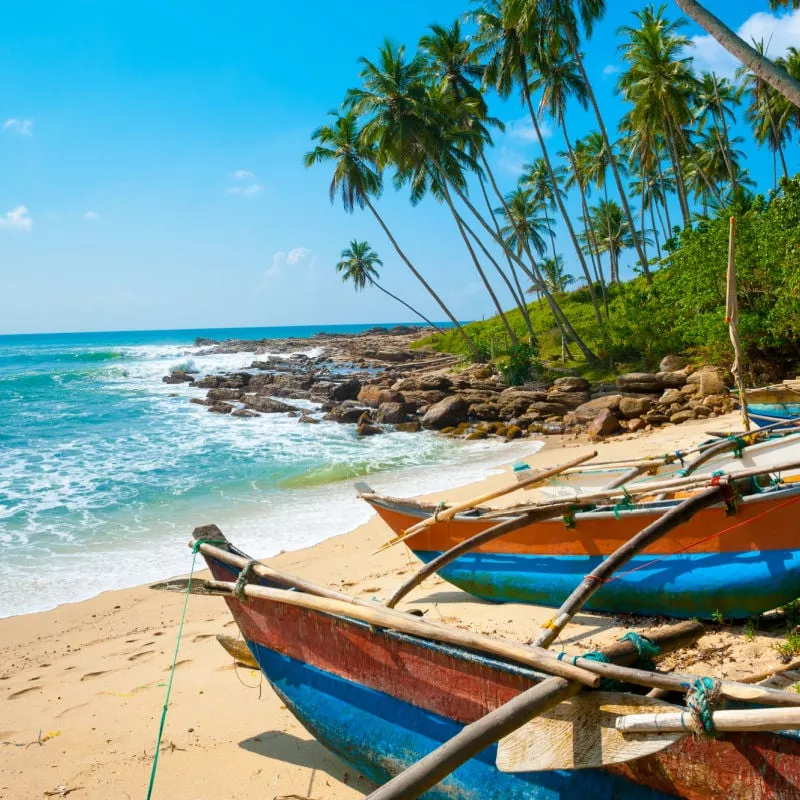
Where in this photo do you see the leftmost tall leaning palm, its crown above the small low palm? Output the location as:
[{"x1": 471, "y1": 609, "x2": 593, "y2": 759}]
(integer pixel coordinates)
[{"x1": 304, "y1": 111, "x2": 481, "y2": 360}]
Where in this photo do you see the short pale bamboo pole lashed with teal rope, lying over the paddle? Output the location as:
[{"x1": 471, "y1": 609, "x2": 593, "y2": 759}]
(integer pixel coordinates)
[{"x1": 615, "y1": 708, "x2": 800, "y2": 733}]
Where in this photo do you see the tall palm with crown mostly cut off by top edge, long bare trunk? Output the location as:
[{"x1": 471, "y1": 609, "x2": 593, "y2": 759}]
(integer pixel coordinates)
[{"x1": 526, "y1": 0, "x2": 650, "y2": 280}]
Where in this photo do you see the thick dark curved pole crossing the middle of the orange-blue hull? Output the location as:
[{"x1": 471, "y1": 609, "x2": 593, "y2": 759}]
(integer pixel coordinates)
[{"x1": 534, "y1": 484, "x2": 730, "y2": 647}]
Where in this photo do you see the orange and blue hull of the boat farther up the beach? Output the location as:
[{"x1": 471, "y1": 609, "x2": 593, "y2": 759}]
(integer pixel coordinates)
[{"x1": 365, "y1": 487, "x2": 800, "y2": 618}]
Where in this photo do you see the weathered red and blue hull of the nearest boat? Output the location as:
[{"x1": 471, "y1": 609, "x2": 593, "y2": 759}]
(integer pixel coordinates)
[{"x1": 202, "y1": 559, "x2": 800, "y2": 800}]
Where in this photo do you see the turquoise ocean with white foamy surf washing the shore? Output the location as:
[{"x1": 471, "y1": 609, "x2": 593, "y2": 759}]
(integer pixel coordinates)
[{"x1": 0, "y1": 325, "x2": 540, "y2": 617}]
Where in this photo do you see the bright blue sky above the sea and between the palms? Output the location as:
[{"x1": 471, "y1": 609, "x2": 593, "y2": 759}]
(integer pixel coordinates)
[{"x1": 0, "y1": 0, "x2": 800, "y2": 334}]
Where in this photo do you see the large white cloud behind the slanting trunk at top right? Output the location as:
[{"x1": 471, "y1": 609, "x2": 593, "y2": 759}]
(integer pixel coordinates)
[{"x1": 692, "y1": 9, "x2": 800, "y2": 78}]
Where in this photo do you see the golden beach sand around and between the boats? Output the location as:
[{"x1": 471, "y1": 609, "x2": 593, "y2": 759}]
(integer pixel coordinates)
[{"x1": 0, "y1": 415, "x2": 783, "y2": 800}]
